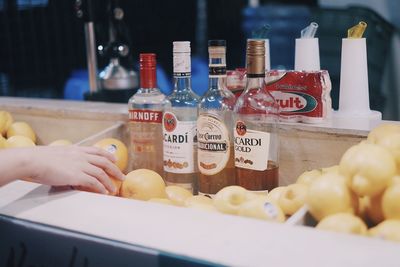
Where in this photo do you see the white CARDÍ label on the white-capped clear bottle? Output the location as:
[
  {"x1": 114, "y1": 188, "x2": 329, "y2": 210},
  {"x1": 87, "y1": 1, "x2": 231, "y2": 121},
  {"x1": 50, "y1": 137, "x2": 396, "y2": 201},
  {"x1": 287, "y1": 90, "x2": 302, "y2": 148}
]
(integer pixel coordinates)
[{"x1": 163, "y1": 112, "x2": 197, "y2": 173}]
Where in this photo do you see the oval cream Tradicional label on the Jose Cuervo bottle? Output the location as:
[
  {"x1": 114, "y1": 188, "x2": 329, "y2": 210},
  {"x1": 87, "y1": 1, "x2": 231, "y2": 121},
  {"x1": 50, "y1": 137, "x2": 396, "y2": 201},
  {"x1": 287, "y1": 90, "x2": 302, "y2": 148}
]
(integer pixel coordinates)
[{"x1": 197, "y1": 115, "x2": 231, "y2": 175}]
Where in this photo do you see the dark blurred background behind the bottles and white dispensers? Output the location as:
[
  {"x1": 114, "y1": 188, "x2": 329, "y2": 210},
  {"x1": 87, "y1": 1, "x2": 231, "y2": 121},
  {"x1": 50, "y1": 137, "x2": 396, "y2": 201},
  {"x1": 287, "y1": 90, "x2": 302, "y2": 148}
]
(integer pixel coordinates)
[{"x1": 0, "y1": 0, "x2": 400, "y2": 120}]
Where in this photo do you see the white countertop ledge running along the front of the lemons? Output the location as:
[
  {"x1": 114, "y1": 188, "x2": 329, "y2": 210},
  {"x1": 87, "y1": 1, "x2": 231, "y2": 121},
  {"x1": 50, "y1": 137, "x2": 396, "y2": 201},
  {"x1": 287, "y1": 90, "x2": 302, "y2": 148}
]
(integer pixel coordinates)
[{"x1": 0, "y1": 181, "x2": 400, "y2": 267}]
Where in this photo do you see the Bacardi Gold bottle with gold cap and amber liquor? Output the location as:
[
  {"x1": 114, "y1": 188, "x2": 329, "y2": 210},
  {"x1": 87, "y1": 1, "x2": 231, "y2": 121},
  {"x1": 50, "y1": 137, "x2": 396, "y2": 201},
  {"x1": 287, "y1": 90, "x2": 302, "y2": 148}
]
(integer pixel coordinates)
[{"x1": 234, "y1": 39, "x2": 279, "y2": 191}]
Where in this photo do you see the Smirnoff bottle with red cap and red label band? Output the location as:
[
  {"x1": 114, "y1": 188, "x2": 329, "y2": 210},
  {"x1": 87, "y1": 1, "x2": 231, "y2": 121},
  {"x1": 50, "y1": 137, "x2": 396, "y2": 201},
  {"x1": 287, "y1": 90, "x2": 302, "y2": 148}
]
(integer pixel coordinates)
[{"x1": 128, "y1": 54, "x2": 167, "y2": 176}]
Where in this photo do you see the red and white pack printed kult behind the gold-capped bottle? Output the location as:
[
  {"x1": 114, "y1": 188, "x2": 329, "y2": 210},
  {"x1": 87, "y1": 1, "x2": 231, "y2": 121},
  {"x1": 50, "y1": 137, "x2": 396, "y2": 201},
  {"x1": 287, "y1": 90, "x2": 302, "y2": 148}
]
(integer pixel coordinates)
[{"x1": 265, "y1": 70, "x2": 332, "y2": 123}]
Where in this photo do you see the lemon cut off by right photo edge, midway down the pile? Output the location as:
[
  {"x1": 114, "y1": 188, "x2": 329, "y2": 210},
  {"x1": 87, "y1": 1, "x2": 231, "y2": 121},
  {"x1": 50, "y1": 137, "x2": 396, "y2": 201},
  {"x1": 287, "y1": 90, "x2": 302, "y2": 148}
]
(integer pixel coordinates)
[{"x1": 382, "y1": 184, "x2": 400, "y2": 219}]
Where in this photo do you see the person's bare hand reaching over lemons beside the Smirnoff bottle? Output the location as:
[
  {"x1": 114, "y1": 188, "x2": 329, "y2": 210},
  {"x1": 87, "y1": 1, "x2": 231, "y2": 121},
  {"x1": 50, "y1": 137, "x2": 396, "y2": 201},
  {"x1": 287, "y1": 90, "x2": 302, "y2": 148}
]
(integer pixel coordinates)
[{"x1": 28, "y1": 146, "x2": 125, "y2": 194}]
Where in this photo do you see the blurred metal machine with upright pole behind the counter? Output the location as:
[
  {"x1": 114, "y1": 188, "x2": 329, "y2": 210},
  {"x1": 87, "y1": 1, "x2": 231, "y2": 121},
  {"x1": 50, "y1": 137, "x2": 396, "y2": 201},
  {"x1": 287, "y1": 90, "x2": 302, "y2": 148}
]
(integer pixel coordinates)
[{"x1": 75, "y1": 0, "x2": 139, "y2": 103}]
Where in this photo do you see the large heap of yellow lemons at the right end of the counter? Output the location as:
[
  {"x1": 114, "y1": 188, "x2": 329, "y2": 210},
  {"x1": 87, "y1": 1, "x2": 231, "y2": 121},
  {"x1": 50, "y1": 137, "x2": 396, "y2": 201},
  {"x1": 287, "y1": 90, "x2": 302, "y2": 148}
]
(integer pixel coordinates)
[{"x1": 297, "y1": 124, "x2": 400, "y2": 244}]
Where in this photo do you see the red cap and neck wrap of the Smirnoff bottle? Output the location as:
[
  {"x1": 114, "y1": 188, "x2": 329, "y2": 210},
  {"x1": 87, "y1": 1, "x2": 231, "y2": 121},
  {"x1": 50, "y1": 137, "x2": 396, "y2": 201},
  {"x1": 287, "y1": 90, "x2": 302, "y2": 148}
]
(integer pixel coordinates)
[{"x1": 140, "y1": 53, "x2": 157, "y2": 88}]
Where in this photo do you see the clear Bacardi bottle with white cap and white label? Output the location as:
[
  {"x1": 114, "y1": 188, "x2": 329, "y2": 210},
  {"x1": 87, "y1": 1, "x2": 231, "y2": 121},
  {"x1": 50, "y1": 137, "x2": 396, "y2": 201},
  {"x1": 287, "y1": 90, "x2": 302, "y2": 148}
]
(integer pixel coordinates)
[{"x1": 163, "y1": 42, "x2": 200, "y2": 193}]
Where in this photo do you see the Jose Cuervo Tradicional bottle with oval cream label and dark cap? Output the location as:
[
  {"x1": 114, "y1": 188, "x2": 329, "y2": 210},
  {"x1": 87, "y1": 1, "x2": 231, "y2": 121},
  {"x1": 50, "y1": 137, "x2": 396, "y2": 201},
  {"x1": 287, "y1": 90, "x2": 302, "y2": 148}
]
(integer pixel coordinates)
[{"x1": 197, "y1": 40, "x2": 236, "y2": 195}]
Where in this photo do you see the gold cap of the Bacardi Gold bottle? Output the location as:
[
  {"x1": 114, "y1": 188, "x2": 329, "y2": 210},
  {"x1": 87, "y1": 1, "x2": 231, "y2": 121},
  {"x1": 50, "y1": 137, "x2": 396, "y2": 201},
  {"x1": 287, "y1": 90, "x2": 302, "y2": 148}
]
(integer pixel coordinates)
[{"x1": 246, "y1": 39, "x2": 265, "y2": 76}]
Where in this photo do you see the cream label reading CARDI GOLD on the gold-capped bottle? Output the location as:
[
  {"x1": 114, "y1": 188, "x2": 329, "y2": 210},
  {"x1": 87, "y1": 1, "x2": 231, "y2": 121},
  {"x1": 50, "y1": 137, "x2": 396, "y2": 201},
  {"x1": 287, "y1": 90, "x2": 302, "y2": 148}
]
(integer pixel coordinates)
[{"x1": 233, "y1": 121, "x2": 270, "y2": 171}]
